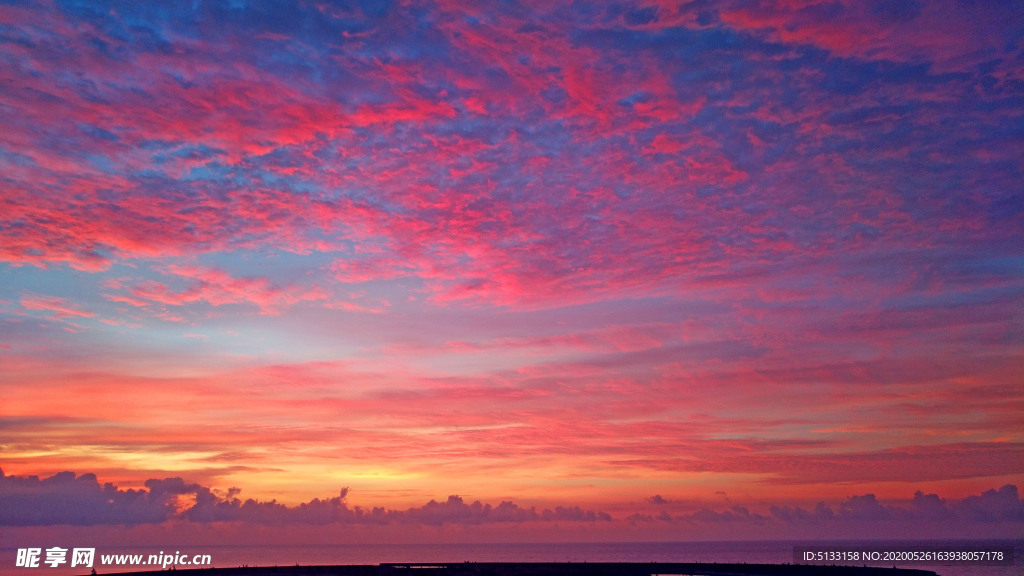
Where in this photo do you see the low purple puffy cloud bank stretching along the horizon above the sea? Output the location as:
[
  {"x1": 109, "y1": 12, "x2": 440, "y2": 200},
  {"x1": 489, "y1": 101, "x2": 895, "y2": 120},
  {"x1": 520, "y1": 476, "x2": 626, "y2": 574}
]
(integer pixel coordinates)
[{"x1": 0, "y1": 471, "x2": 1024, "y2": 534}]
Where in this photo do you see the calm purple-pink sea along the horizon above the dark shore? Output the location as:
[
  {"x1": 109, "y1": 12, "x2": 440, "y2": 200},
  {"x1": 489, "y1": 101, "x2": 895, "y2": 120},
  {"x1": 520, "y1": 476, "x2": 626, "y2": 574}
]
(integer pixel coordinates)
[{"x1": 0, "y1": 540, "x2": 1024, "y2": 576}]
